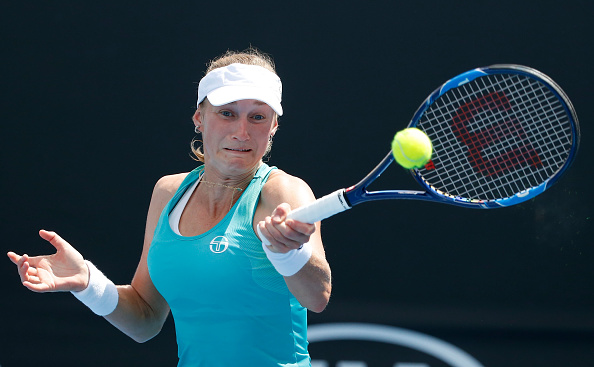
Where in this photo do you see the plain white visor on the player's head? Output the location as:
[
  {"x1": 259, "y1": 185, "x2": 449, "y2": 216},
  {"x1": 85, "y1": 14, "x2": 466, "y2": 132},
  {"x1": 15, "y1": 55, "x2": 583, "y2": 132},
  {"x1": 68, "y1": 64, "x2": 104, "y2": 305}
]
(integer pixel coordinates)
[{"x1": 198, "y1": 64, "x2": 283, "y2": 116}]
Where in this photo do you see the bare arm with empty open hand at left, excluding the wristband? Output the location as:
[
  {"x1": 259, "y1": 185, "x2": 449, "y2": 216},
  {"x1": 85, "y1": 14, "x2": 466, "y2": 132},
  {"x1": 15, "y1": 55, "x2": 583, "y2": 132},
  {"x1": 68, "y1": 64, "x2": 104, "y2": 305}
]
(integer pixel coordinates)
[{"x1": 8, "y1": 174, "x2": 186, "y2": 342}]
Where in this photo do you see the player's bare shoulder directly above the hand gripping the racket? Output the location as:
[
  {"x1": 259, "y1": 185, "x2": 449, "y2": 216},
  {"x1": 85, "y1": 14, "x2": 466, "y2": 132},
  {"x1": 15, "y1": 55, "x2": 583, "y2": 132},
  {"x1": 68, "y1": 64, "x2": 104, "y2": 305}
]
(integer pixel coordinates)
[{"x1": 262, "y1": 169, "x2": 315, "y2": 208}]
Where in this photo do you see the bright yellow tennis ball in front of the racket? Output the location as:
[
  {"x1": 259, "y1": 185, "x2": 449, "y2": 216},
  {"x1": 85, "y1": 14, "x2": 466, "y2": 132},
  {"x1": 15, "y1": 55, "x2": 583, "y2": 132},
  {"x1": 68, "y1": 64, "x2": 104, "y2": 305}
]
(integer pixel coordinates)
[{"x1": 392, "y1": 127, "x2": 433, "y2": 169}]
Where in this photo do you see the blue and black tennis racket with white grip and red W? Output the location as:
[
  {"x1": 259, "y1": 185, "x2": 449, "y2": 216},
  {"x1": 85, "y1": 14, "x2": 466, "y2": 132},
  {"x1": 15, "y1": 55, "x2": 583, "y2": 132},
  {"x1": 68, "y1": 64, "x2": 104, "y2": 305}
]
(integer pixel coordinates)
[{"x1": 288, "y1": 65, "x2": 580, "y2": 223}]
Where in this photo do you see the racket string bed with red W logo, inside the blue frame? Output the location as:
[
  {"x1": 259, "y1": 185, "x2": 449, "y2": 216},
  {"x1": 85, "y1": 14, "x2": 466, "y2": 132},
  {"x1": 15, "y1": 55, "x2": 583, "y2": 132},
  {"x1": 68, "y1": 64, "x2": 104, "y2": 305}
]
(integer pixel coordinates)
[{"x1": 417, "y1": 74, "x2": 572, "y2": 201}]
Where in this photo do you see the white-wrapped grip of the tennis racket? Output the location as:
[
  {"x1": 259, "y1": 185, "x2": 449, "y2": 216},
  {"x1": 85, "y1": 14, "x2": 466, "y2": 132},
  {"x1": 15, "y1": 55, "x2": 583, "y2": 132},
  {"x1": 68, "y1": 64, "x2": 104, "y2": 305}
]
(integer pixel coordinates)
[{"x1": 287, "y1": 189, "x2": 351, "y2": 223}]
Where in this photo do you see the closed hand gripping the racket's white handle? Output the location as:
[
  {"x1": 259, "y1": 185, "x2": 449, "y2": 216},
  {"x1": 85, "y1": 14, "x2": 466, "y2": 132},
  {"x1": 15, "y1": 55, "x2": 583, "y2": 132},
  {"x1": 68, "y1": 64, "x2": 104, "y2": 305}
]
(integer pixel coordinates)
[{"x1": 258, "y1": 203, "x2": 316, "y2": 253}]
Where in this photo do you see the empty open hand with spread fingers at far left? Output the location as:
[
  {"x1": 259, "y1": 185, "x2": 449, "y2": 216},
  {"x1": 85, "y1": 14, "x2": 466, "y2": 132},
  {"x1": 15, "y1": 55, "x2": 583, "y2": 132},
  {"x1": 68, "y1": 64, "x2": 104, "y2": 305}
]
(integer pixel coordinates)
[{"x1": 7, "y1": 230, "x2": 89, "y2": 292}]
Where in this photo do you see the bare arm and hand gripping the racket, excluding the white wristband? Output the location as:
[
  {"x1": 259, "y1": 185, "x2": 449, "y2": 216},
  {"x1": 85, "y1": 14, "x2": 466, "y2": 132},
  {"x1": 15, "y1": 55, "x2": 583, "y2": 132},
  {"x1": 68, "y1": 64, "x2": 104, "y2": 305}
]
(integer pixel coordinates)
[{"x1": 254, "y1": 171, "x2": 332, "y2": 312}]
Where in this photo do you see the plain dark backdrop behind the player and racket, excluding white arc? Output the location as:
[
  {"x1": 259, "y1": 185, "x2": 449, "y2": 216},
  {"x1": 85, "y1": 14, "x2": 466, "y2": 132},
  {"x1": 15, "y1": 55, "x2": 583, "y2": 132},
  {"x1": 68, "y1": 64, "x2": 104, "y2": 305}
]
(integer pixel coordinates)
[{"x1": 0, "y1": 0, "x2": 594, "y2": 367}]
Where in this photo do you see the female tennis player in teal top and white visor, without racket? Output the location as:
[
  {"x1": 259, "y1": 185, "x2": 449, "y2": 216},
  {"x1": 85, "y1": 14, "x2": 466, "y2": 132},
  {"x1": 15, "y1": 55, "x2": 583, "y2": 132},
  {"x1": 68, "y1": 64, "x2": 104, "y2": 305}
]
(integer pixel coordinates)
[{"x1": 8, "y1": 50, "x2": 331, "y2": 367}]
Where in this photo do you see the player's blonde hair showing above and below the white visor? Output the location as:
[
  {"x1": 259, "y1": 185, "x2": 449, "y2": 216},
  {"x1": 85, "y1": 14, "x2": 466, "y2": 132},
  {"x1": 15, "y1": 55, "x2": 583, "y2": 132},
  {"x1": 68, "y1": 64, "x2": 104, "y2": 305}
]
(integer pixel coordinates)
[{"x1": 190, "y1": 47, "x2": 278, "y2": 163}]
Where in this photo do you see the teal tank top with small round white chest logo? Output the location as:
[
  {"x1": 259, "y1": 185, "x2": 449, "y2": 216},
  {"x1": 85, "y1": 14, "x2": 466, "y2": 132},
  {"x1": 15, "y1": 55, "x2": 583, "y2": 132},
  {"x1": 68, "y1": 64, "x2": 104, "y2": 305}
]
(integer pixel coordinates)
[{"x1": 147, "y1": 164, "x2": 310, "y2": 367}]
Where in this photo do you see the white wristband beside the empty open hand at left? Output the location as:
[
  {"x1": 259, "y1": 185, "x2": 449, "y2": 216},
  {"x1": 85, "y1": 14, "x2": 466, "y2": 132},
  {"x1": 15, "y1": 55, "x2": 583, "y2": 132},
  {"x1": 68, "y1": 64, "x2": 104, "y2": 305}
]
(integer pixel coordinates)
[{"x1": 70, "y1": 260, "x2": 118, "y2": 316}]
